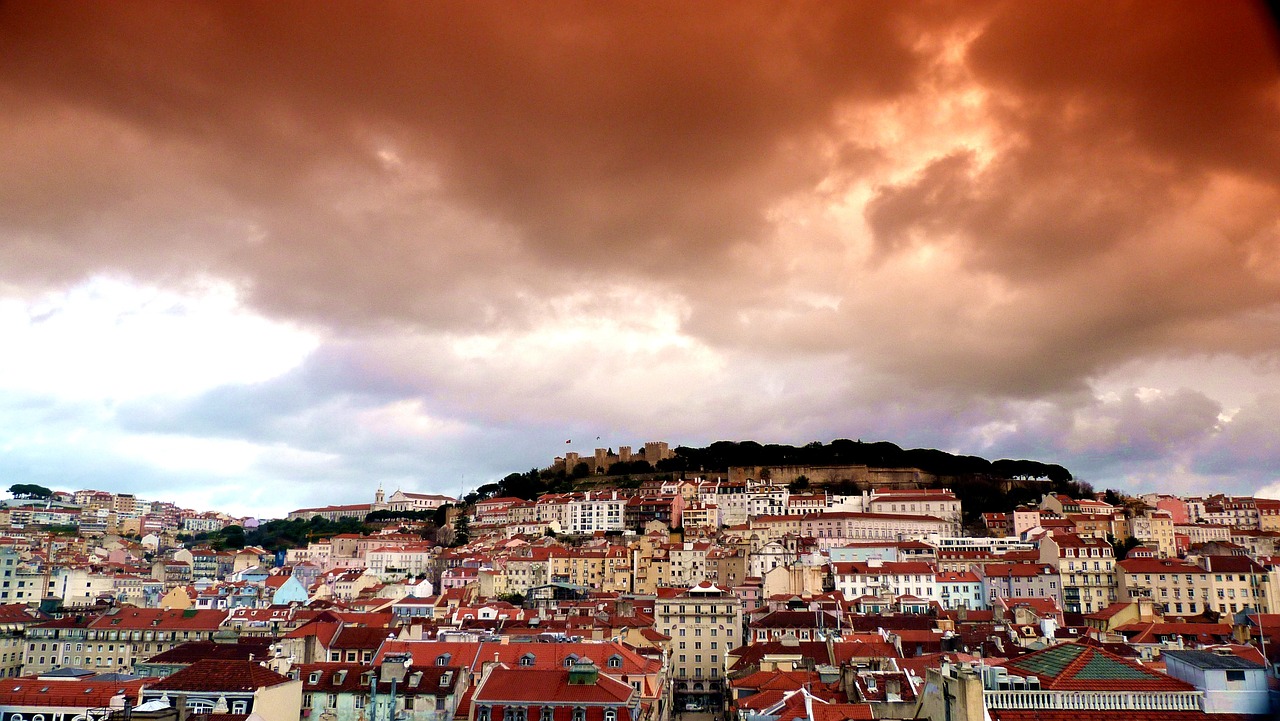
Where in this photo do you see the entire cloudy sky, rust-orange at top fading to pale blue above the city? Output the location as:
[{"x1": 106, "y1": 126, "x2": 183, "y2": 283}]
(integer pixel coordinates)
[{"x1": 0, "y1": 0, "x2": 1280, "y2": 517}]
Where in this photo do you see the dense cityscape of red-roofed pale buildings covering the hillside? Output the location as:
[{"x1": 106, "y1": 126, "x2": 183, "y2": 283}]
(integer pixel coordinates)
[{"x1": 0, "y1": 444, "x2": 1280, "y2": 721}]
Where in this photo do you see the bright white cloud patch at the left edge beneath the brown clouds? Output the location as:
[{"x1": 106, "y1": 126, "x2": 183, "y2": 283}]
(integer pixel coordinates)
[{"x1": 0, "y1": 277, "x2": 319, "y2": 401}]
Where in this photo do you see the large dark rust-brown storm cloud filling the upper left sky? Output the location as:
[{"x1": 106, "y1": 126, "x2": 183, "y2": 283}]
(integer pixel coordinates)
[{"x1": 4, "y1": 3, "x2": 919, "y2": 267}]
